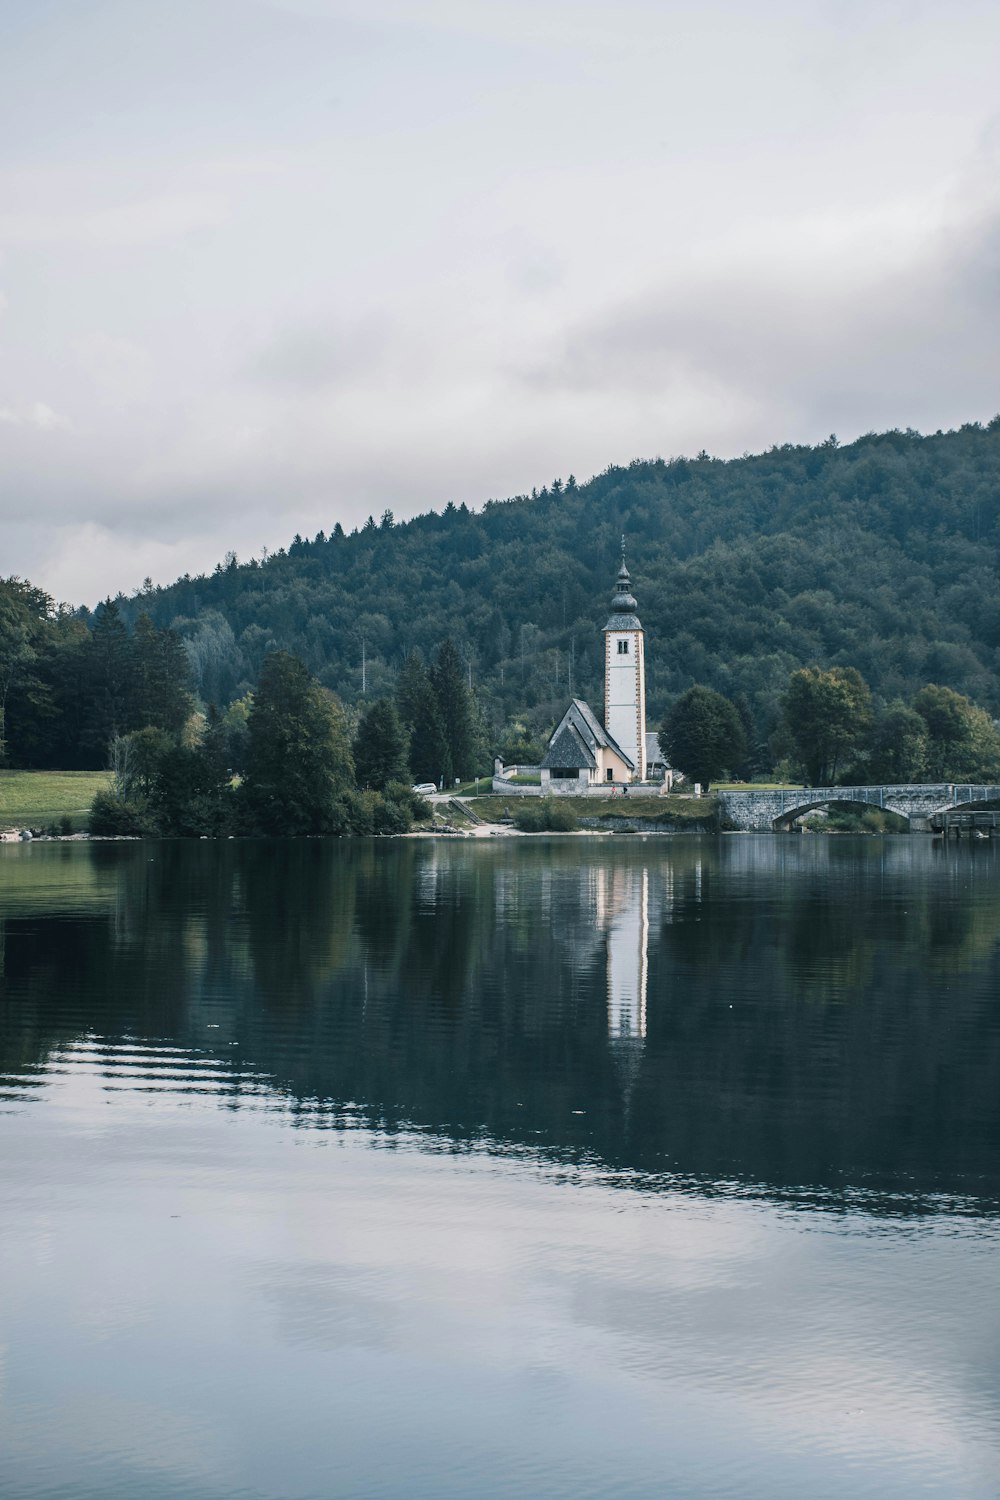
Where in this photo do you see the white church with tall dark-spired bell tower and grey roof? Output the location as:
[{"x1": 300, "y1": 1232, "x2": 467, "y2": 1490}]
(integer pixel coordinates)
[{"x1": 541, "y1": 545, "x2": 670, "y2": 795}]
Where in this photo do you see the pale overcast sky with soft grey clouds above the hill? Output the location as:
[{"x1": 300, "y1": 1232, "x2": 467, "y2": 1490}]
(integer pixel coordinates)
[{"x1": 0, "y1": 0, "x2": 1000, "y2": 603}]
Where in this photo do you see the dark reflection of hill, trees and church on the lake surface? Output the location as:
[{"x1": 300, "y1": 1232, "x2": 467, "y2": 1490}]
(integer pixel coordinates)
[{"x1": 0, "y1": 837, "x2": 1000, "y2": 1208}]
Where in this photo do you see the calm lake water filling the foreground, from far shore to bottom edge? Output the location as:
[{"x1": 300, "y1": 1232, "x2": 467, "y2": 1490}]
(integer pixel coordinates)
[{"x1": 0, "y1": 836, "x2": 1000, "y2": 1500}]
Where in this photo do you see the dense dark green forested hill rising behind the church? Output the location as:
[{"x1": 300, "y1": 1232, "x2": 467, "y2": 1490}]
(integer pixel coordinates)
[{"x1": 109, "y1": 417, "x2": 1000, "y2": 728}]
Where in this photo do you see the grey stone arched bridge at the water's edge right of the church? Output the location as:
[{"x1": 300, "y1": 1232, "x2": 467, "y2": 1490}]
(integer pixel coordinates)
[{"x1": 718, "y1": 782, "x2": 1000, "y2": 833}]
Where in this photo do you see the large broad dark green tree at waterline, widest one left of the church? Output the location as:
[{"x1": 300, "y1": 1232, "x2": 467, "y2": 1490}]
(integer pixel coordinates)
[{"x1": 240, "y1": 651, "x2": 354, "y2": 836}]
